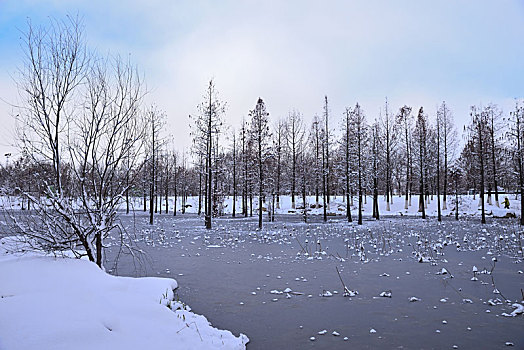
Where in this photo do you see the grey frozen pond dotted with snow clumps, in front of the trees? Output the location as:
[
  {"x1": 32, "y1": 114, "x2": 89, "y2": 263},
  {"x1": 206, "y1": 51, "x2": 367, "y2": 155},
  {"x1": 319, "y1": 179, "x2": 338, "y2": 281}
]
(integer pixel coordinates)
[{"x1": 106, "y1": 213, "x2": 524, "y2": 349}]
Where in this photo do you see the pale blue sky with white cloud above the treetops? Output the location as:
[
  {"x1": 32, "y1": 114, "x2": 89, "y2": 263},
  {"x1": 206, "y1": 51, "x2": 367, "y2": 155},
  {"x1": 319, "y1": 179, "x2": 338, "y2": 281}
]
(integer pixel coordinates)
[{"x1": 0, "y1": 0, "x2": 524, "y2": 160}]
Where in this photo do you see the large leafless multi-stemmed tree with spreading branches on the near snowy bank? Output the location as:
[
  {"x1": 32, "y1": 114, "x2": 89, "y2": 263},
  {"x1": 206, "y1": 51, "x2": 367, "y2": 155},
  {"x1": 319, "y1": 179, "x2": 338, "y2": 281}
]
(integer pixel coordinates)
[{"x1": 11, "y1": 18, "x2": 144, "y2": 267}]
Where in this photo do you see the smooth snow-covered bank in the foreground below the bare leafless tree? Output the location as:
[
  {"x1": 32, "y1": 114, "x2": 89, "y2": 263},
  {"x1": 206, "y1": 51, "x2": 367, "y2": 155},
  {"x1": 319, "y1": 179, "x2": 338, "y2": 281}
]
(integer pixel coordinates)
[{"x1": 0, "y1": 238, "x2": 249, "y2": 350}]
